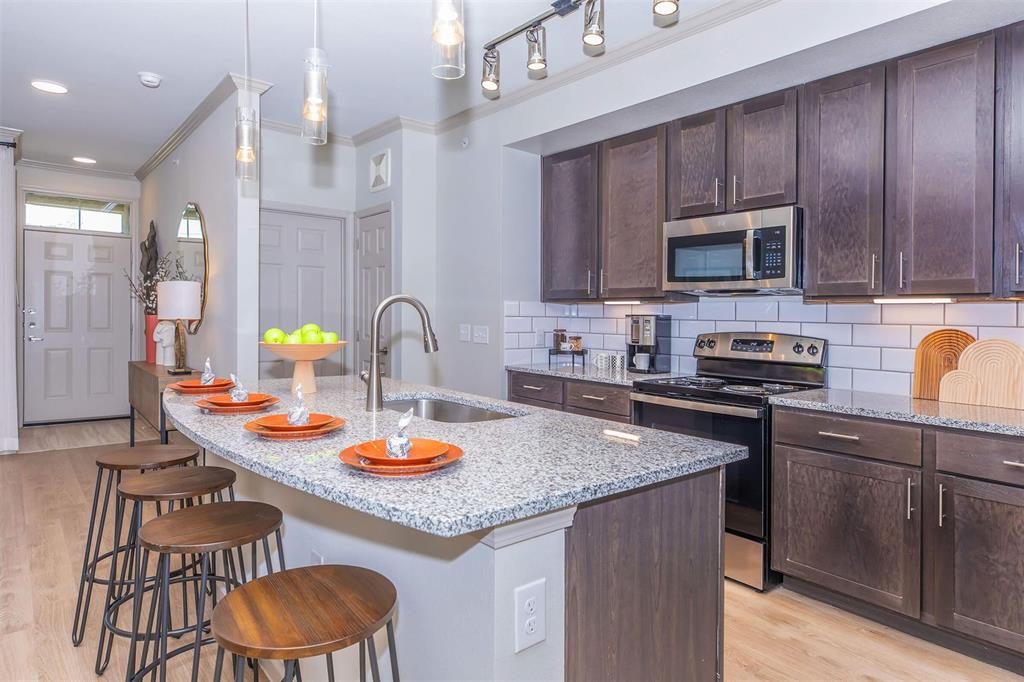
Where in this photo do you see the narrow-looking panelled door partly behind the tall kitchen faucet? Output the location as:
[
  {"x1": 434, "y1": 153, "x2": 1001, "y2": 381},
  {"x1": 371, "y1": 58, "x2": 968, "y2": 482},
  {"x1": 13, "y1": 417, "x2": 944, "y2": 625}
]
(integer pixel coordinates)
[{"x1": 354, "y1": 211, "x2": 393, "y2": 375}]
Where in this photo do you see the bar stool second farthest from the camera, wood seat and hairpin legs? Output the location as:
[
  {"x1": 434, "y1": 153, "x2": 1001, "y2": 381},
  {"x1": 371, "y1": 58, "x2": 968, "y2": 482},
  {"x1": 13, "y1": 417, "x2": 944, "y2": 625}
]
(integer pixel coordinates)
[{"x1": 95, "y1": 466, "x2": 236, "y2": 675}]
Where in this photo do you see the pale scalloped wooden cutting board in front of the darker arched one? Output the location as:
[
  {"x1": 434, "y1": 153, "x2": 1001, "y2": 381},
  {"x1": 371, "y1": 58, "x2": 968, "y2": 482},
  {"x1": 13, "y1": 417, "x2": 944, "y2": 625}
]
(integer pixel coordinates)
[{"x1": 939, "y1": 339, "x2": 1024, "y2": 410}]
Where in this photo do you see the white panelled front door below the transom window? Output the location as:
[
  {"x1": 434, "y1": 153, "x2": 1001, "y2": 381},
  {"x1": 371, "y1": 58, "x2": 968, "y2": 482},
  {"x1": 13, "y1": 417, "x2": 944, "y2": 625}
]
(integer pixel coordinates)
[{"x1": 23, "y1": 230, "x2": 131, "y2": 423}]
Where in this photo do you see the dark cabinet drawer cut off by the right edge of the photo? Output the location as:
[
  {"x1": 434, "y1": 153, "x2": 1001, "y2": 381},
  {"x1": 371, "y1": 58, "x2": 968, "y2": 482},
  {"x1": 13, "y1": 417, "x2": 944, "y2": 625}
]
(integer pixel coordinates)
[{"x1": 935, "y1": 431, "x2": 1024, "y2": 485}]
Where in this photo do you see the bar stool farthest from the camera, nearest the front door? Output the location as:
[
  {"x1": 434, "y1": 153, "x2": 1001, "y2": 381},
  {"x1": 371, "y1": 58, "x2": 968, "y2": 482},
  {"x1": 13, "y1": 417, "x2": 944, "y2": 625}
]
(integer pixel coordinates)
[{"x1": 71, "y1": 445, "x2": 199, "y2": 646}]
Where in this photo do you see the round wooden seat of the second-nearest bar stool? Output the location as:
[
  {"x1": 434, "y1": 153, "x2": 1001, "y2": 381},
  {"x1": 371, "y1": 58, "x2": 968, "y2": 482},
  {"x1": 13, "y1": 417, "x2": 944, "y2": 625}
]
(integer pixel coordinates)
[{"x1": 138, "y1": 497, "x2": 283, "y2": 554}]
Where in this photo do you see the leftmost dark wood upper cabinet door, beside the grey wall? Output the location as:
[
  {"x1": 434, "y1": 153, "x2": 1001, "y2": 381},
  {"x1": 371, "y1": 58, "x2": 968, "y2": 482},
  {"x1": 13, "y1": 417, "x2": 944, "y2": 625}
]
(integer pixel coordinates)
[{"x1": 542, "y1": 144, "x2": 599, "y2": 300}]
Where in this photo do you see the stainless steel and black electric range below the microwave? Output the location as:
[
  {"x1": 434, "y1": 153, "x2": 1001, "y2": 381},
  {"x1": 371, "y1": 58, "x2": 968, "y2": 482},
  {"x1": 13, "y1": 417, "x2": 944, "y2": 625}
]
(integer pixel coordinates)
[{"x1": 631, "y1": 332, "x2": 826, "y2": 590}]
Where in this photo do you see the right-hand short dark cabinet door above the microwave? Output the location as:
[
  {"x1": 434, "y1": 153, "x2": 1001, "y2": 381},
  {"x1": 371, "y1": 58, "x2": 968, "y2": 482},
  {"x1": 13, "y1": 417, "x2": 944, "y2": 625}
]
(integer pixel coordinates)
[{"x1": 727, "y1": 89, "x2": 797, "y2": 211}]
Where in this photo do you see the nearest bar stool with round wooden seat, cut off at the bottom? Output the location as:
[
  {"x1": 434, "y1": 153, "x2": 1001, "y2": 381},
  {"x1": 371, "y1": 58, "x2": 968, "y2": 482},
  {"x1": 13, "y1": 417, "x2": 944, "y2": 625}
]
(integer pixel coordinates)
[{"x1": 211, "y1": 565, "x2": 398, "y2": 682}]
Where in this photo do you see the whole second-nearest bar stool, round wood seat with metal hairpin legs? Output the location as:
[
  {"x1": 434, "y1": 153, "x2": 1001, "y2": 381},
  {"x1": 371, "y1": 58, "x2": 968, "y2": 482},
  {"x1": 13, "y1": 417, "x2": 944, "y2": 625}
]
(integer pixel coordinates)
[{"x1": 128, "y1": 502, "x2": 285, "y2": 682}]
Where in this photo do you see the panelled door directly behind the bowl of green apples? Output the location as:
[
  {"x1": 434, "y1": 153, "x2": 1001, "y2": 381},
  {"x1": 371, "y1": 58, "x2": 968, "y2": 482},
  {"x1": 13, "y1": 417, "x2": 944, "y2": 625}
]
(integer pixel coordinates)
[{"x1": 260, "y1": 209, "x2": 344, "y2": 379}]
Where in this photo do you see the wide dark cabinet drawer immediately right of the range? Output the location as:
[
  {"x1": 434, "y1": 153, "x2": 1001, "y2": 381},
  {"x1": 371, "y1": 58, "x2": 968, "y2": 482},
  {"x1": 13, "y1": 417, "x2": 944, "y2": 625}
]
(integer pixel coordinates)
[{"x1": 773, "y1": 411, "x2": 921, "y2": 466}]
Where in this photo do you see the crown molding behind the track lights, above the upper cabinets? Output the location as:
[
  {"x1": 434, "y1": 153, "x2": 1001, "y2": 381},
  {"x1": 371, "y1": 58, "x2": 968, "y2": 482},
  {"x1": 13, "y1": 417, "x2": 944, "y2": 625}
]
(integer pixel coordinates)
[{"x1": 436, "y1": 0, "x2": 781, "y2": 135}]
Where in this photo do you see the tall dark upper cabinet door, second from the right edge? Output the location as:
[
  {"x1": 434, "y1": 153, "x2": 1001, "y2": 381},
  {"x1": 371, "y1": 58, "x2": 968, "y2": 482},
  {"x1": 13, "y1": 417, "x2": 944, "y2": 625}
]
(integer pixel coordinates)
[{"x1": 886, "y1": 34, "x2": 995, "y2": 295}]
